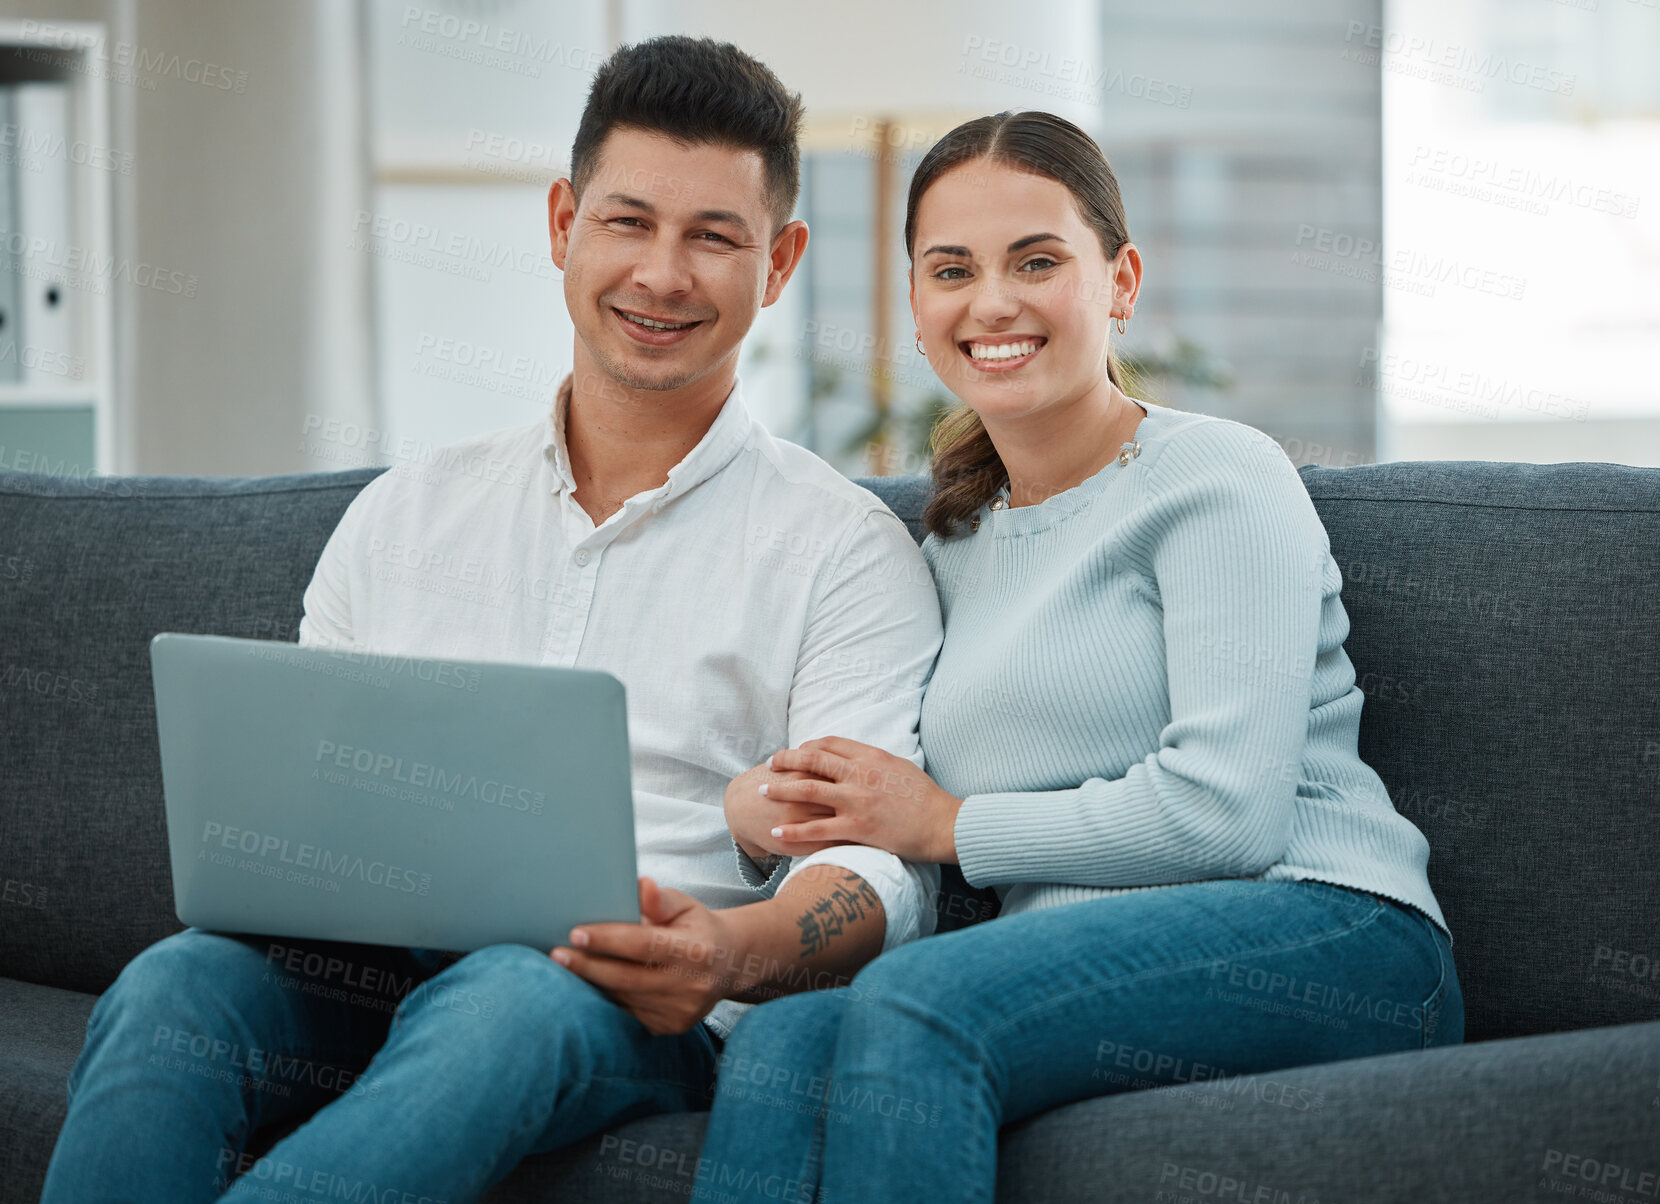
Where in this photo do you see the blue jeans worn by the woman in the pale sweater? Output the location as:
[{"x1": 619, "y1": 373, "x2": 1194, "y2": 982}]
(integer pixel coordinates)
[{"x1": 692, "y1": 880, "x2": 1464, "y2": 1204}]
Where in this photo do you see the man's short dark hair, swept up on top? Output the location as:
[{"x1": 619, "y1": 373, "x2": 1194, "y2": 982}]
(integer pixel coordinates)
[{"x1": 571, "y1": 35, "x2": 802, "y2": 231}]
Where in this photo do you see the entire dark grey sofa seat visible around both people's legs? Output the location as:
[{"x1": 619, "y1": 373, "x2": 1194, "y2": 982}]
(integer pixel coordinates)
[{"x1": 0, "y1": 978, "x2": 1660, "y2": 1204}]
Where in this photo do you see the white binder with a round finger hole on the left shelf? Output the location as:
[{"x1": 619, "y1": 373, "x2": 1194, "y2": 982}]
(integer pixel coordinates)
[{"x1": 12, "y1": 80, "x2": 81, "y2": 385}]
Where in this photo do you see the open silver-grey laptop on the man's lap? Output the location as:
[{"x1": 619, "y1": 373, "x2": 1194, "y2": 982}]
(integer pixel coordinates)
[{"x1": 149, "y1": 631, "x2": 639, "y2": 952}]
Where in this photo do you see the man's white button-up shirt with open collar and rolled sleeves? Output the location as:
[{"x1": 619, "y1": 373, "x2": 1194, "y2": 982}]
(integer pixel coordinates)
[{"x1": 299, "y1": 379, "x2": 941, "y2": 1036}]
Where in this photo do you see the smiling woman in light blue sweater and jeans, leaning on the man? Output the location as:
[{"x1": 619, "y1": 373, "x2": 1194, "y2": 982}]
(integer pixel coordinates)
[{"x1": 699, "y1": 113, "x2": 1464, "y2": 1204}]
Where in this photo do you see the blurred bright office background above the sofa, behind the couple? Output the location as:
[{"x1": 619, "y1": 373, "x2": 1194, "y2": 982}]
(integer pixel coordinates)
[{"x1": 0, "y1": 0, "x2": 1660, "y2": 475}]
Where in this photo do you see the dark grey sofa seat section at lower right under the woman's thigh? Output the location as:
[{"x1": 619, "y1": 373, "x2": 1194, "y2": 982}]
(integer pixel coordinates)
[{"x1": 998, "y1": 1025, "x2": 1660, "y2": 1204}]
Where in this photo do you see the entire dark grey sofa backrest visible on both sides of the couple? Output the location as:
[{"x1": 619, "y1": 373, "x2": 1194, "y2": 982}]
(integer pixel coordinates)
[{"x1": 0, "y1": 463, "x2": 1660, "y2": 1040}]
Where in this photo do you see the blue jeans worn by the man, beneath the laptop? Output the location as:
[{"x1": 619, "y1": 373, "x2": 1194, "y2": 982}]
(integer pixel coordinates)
[{"x1": 42, "y1": 928, "x2": 719, "y2": 1204}]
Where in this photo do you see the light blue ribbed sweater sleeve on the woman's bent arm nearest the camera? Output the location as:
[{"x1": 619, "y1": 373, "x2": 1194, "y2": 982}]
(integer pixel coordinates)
[{"x1": 955, "y1": 422, "x2": 1330, "y2": 887}]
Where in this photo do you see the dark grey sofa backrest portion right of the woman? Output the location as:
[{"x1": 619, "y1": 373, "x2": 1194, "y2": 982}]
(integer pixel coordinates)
[{"x1": 1301, "y1": 462, "x2": 1660, "y2": 1040}]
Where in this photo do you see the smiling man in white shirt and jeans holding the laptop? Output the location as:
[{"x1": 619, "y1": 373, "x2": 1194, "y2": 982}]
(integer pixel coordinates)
[{"x1": 45, "y1": 38, "x2": 940, "y2": 1204}]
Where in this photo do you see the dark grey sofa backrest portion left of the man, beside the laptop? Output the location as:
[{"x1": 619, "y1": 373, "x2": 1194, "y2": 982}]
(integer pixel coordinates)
[{"x1": 0, "y1": 468, "x2": 382, "y2": 991}]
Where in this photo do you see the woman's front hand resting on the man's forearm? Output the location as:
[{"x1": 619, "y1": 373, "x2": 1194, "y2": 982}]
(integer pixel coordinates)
[{"x1": 757, "y1": 736, "x2": 963, "y2": 864}]
